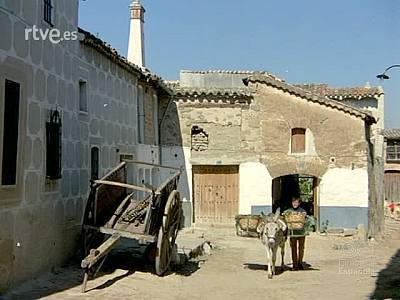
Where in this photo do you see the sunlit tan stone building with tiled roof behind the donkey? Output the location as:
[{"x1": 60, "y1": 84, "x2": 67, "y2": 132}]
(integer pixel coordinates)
[{"x1": 161, "y1": 71, "x2": 383, "y2": 234}]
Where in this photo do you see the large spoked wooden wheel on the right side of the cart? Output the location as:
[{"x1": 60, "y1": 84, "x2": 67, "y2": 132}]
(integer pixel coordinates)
[{"x1": 156, "y1": 190, "x2": 181, "y2": 276}]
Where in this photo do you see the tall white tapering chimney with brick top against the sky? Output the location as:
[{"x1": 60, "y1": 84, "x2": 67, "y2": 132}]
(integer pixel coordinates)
[{"x1": 128, "y1": 0, "x2": 145, "y2": 67}]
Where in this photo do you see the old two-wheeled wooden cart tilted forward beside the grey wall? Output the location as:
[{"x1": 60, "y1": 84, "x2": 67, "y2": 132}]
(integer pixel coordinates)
[{"x1": 81, "y1": 160, "x2": 181, "y2": 292}]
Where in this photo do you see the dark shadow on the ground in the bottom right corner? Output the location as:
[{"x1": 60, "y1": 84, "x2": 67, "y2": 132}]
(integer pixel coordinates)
[{"x1": 370, "y1": 249, "x2": 400, "y2": 300}]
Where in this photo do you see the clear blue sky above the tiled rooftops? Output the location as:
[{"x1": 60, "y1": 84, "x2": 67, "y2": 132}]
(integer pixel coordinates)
[{"x1": 79, "y1": 0, "x2": 400, "y2": 127}]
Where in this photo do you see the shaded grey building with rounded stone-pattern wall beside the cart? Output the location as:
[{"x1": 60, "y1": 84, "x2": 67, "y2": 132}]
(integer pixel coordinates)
[{"x1": 0, "y1": 0, "x2": 170, "y2": 294}]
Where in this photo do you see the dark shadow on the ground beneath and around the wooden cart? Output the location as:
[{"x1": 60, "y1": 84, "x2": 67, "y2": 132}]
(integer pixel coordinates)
[{"x1": 0, "y1": 240, "x2": 202, "y2": 300}]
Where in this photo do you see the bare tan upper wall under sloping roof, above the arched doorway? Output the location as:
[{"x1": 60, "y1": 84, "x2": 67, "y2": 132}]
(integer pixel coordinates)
[{"x1": 253, "y1": 85, "x2": 367, "y2": 177}]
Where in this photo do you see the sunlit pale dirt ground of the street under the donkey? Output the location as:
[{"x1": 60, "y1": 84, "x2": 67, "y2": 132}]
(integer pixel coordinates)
[{"x1": 0, "y1": 220, "x2": 400, "y2": 300}]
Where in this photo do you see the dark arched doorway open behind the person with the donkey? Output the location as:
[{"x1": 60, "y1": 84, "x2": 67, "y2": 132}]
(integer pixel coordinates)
[{"x1": 272, "y1": 174, "x2": 319, "y2": 219}]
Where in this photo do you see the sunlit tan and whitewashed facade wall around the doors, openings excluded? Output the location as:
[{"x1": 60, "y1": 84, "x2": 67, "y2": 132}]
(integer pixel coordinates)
[{"x1": 162, "y1": 81, "x2": 370, "y2": 227}]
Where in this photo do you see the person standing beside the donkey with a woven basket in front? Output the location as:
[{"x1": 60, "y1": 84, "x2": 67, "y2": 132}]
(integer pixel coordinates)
[{"x1": 283, "y1": 197, "x2": 315, "y2": 271}]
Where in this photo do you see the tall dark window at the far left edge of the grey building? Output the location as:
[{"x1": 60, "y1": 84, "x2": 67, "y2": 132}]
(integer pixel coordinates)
[{"x1": 1, "y1": 80, "x2": 20, "y2": 185}]
